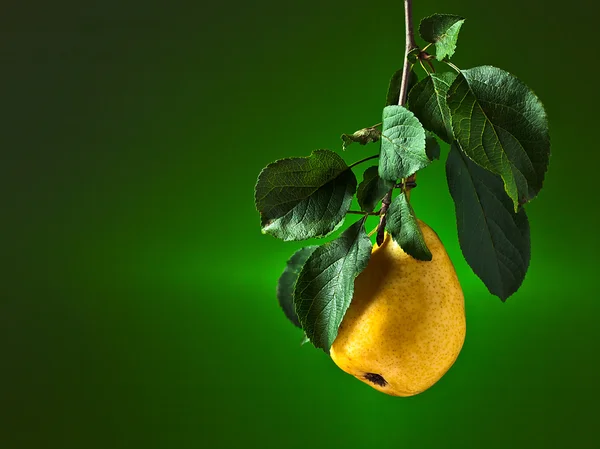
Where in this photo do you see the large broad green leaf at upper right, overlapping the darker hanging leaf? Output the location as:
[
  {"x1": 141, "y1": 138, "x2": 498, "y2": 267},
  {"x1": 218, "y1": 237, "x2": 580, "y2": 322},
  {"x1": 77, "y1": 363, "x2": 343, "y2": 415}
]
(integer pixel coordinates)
[{"x1": 448, "y1": 66, "x2": 550, "y2": 211}]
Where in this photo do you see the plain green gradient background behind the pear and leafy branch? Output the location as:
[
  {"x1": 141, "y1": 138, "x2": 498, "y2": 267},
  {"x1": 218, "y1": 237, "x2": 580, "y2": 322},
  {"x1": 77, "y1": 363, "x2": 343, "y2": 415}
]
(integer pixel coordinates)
[{"x1": 0, "y1": 0, "x2": 600, "y2": 449}]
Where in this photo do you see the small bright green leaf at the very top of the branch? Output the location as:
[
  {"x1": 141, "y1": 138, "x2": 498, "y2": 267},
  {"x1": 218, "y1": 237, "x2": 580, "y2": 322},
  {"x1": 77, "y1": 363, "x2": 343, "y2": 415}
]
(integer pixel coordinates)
[{"x1": 419, "y1": 14, "x2": 465, "y2": 61}]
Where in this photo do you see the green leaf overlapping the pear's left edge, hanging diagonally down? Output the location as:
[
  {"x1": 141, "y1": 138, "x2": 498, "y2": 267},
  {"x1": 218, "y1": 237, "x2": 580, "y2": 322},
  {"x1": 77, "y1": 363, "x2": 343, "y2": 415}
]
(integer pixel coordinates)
[{"x1": 294, "y1": 218, "x2": 372, "y2": 351}]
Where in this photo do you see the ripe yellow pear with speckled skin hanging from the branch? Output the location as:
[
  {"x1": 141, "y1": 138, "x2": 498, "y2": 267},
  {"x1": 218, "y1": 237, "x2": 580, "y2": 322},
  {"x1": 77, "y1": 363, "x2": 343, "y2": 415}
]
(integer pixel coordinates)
[{"x1": 330, "y1": 220, "x2": 466, "y2": 396}]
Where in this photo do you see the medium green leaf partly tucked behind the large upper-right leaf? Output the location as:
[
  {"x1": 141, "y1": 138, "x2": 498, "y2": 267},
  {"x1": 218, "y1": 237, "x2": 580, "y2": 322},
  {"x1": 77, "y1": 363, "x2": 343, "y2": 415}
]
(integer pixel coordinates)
[{"x1": 408, "y1": 72, "x2": 457, "y2": 143}]
